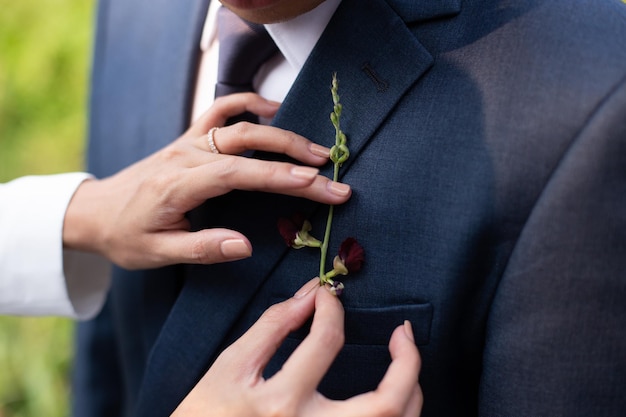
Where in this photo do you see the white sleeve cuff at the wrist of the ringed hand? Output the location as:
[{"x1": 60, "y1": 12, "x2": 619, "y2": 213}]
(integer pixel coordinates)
[{"x1": 0, "y1": 173, "x2": 110, "y2": 319}]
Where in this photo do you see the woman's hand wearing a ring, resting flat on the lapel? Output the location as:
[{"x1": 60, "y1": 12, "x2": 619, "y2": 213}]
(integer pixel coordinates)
[{"x1": 63, "y1": 93, "x2": 350, "y2": 269}]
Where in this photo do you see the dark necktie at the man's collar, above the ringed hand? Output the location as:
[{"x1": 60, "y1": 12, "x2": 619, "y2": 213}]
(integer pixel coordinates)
[{"x1": 215, "y1": 7, "x2": 278, "y2": 97}]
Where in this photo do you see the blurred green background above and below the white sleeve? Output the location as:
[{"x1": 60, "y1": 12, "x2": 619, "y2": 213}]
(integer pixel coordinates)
[{"x1": 0, "y1": 0, "x2": 95, "y2": 417}]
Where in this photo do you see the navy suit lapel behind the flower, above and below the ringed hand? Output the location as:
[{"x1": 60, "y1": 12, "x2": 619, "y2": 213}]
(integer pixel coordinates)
[{"x1": 138, "y1": 0, "x2": 458, "y2": 415}]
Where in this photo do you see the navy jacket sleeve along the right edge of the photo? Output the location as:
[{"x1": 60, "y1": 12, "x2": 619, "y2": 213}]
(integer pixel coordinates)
[{"x1": 480, "y1": 77, "x2": 626, "y2": 416}]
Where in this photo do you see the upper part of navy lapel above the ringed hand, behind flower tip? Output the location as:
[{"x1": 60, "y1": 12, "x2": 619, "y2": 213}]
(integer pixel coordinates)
[{"x1": 274, "y1": 0, "x2": 444, "y2": 172}]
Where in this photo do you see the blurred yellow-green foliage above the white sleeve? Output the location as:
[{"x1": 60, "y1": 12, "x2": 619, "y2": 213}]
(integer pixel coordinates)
[{"x1": 0, "y1": 0, "x2": 94, "y2": 181}]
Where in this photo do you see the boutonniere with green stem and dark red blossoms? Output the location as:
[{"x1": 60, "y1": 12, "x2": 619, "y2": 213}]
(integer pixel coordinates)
[{"x1": 278, "y1": 74, "x2": 365, "y2": 295}]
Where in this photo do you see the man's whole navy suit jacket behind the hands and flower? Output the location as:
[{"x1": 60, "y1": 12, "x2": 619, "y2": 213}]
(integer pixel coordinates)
[{"x1": 74, "y1": 0, "x2": 626, "y2": 417}]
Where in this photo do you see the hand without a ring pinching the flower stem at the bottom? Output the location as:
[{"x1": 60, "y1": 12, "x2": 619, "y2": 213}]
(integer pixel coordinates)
[{"x1": 172, "y1": 278, "x2": 423, "y2": 417}]
